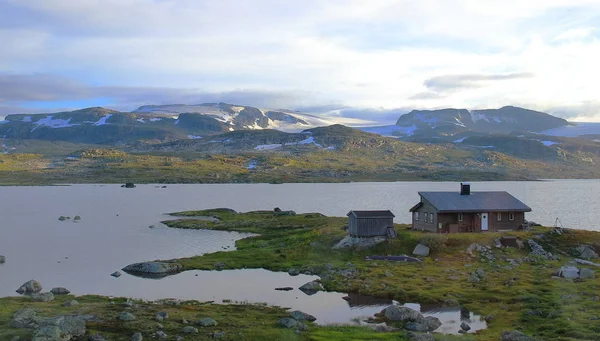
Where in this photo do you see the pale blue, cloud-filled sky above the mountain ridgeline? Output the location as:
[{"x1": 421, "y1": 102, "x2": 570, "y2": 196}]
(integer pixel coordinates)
[{"x1": 0, "y1": 0, "x2": 600, "y2": 121}]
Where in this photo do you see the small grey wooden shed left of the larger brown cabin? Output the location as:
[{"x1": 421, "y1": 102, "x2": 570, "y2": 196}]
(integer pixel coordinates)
[{"x1": 347, "y1": 210, "x2": 395, "y2": 238}]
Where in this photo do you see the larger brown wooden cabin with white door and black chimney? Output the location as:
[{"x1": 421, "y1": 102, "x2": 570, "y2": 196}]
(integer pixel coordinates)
[{"x1": 410, "y1": 183, "x2": 531, "y2": 233}]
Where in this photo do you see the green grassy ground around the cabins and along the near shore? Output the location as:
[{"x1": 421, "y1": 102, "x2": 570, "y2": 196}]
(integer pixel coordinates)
[{"x1": 0, "y1": 209, "x2": 600, "y2": 341}]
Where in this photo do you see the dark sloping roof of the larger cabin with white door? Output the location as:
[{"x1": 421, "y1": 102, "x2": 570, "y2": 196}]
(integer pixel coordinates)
[{"x1": 419, "y1": 192, "x2": 531, "y2": 212}]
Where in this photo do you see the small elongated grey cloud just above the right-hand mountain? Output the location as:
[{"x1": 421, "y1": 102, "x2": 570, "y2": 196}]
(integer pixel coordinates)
[{"x1": 424, "y1": 72, "x2": 533, "y2": 92}]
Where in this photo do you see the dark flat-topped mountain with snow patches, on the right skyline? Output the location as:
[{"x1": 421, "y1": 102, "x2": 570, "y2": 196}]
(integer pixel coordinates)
[{"x1": 394, "y1": 106, "x2": 569, "y2": 137}]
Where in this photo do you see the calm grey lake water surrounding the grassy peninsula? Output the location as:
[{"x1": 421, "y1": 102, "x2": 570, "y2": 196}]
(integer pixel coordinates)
[{"x1": 0, "y1": 180, "x2": 600, "y2": 328}]
